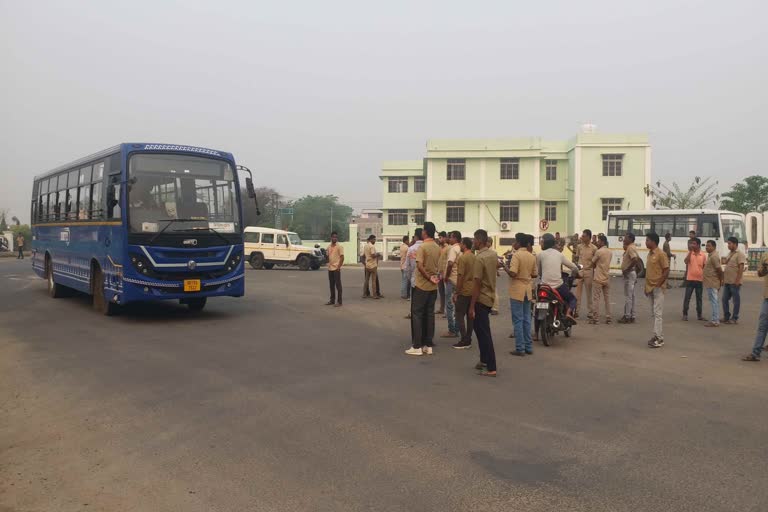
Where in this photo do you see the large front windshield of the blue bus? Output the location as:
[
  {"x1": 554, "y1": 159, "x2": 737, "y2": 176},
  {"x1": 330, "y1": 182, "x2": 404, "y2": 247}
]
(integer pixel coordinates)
[{"x1": 128, "y1": 153, "x2": 240, "y2": 233}]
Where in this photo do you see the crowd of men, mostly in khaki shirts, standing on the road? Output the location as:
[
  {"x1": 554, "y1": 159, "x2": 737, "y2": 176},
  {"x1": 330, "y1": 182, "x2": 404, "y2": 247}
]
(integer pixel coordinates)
[{"x1": 327, "y1": 222, "x2": 768, "y2": 377}]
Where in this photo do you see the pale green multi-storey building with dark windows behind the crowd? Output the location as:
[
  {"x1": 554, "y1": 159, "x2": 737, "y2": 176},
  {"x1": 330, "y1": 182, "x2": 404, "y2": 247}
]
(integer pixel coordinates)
[{"x1": 380, "y1": 132, "x2": 651, "y2": 252}]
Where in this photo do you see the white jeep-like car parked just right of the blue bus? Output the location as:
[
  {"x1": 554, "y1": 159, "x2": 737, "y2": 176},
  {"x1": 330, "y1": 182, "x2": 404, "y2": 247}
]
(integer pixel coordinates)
[{"x1": 243, "y1": 226, "x2": 325, "y2": 270}]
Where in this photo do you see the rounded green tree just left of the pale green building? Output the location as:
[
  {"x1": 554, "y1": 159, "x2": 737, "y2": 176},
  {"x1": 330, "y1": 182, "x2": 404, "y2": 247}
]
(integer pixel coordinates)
[{"x1": 290, "y1": 195, "x2": 352, "y2": 240}]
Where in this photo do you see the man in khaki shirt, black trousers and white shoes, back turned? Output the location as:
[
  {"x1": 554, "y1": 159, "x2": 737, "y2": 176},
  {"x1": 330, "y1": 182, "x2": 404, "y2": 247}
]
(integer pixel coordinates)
[{"x1": 405, "y1": 222, "x2": 440, "y2": 356}]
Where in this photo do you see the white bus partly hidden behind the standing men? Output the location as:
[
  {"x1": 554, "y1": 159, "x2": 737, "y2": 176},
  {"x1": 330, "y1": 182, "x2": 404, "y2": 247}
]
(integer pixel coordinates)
[{"x1": 605, "y1": 210, "x2": 747, "y2": 276}]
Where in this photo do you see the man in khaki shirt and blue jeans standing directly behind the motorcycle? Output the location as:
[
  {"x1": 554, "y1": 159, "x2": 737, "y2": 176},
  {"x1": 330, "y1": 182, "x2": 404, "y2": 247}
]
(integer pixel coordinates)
[{"x1": 504, "y1": 233, "x2": 538, "y2": 357}]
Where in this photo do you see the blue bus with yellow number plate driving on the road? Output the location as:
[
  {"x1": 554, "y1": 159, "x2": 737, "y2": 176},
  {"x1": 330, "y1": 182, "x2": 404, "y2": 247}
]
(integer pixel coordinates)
[{"x1": 31, "y1": 143, "x2": 258, "y2": 315}]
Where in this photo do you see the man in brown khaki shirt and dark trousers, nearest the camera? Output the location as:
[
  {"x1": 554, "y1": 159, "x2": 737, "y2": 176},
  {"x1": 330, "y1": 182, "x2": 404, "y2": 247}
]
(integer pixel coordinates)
[{"x1": 469, "y1": 229, "x2": 499, "y2": 377}]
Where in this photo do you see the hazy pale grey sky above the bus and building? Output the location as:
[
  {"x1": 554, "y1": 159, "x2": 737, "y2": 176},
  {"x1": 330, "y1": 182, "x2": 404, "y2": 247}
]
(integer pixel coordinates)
[{"x1": 0, "y1": 0, "x2": 768, "y2": 221}]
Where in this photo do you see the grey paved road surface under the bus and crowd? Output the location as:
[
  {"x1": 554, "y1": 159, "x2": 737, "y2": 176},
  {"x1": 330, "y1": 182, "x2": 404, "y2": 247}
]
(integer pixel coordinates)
[{"x1": 0, "y1": 260, "x2": 768, "y2": 512}]
